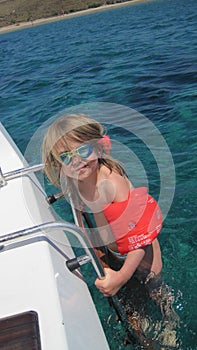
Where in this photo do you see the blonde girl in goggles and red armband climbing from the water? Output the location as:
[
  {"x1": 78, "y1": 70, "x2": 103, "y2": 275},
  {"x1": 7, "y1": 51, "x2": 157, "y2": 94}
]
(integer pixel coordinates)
[{"x1": 43, "y1": 114, "x2": 162, "y2": 296}]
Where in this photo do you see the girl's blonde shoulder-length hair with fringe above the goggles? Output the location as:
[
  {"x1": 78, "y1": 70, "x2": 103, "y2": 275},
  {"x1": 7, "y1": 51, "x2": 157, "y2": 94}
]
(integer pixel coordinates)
[{"x1": 42, "y1": 114, "x2": 125, "y2": 187}]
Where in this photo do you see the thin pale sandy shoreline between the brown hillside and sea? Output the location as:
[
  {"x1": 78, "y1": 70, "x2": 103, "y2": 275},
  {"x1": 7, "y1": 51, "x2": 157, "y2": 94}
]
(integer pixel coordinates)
[{"x1": 0, "y1": 0, "x2": 151, "y2": 34}]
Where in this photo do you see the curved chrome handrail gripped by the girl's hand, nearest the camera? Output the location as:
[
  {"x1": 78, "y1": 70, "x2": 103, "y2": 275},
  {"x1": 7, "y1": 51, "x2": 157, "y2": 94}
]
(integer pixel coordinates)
[{"x1": 0, "y1": 221, "x2": 105, "y2": 278}]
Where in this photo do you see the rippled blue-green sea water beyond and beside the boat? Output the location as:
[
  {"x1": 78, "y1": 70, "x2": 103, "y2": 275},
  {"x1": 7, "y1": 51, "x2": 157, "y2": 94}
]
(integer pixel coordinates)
[{"x1": 0, "y1": 0, "x2": 197, "y2": 350}]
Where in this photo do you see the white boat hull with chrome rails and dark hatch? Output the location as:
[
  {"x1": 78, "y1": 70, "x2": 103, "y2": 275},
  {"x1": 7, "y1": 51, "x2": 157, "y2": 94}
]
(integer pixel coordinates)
[{"x1": 0, "y1": 121, "x2": 109, "y2": 350}]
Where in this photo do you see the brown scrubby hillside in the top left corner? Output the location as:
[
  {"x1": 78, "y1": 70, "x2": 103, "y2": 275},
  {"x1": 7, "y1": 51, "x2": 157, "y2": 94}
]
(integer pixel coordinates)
[{"x1": 0, "y1": 0, "x2": 125, "y2": 27}]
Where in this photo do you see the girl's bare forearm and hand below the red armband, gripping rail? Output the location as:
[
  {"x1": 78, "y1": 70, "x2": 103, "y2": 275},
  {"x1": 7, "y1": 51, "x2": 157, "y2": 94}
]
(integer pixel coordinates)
[{"x1": 95, "y1": 249, "x2": 145, "y2": 297}]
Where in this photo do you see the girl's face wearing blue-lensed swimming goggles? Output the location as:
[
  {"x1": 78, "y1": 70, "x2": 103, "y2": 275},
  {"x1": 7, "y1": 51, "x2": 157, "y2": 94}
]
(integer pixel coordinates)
[{"x1": 56, "y1": 140, "x2": 98, "y2": 181}]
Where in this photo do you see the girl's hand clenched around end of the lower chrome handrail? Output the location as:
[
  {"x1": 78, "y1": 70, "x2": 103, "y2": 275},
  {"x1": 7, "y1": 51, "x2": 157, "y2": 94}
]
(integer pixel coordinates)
[{"x1": 95, "y1": 268, "x2": 126, "y2": 297}]
